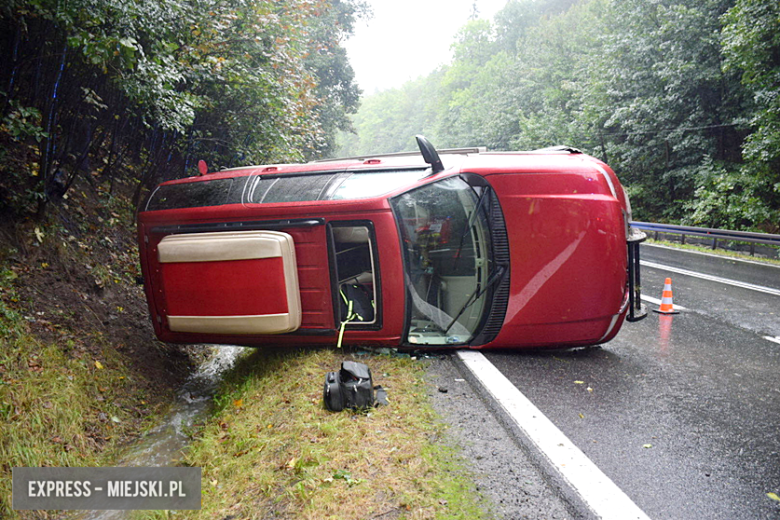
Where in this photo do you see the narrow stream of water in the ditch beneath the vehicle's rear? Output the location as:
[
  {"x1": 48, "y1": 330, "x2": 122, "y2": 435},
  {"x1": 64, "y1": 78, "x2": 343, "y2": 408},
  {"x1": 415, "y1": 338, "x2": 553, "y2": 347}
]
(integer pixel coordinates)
[{"x1": 75, "y1": 347, "x2": 247, "y2": 520}]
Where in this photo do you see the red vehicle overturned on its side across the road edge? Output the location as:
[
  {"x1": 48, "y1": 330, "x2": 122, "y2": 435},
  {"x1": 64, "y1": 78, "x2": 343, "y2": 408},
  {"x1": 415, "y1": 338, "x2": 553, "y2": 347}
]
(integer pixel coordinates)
[{"x1": 138, "y1": 136, "x2": 646, "y2": 349}]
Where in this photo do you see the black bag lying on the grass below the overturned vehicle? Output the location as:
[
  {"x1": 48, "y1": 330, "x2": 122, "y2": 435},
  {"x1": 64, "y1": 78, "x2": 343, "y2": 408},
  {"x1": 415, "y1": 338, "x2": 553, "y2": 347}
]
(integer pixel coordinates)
[{"x1": 322, "y1": 361, "x2": 374, "y2": 412}]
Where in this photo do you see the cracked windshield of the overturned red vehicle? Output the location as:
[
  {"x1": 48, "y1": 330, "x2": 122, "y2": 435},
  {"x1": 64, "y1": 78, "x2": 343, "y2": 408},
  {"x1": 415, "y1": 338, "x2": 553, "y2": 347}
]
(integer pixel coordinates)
[{"x1": 392, "y1": 177, "x2": 500, "y2": 345}]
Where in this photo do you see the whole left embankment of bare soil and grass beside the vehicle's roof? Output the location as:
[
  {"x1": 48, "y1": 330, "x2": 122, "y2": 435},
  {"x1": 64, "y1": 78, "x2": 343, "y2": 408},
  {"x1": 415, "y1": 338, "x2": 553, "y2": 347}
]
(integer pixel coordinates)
[{"x1": 0, "y1": 181, "x2": 195, "y2": 518}]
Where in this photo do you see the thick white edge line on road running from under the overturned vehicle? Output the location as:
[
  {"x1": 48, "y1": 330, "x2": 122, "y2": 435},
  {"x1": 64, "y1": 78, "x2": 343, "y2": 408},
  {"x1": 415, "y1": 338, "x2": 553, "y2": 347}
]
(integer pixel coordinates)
[{"x1": 458, "y1": 350, "x2": 650, "y2": 520}]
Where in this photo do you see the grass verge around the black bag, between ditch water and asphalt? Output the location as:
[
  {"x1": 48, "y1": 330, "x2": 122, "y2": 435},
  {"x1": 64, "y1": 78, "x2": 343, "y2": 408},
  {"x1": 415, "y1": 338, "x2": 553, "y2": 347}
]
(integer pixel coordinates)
[{"x1": 138, "y1": 350, "x2": 486, "y2": 520}]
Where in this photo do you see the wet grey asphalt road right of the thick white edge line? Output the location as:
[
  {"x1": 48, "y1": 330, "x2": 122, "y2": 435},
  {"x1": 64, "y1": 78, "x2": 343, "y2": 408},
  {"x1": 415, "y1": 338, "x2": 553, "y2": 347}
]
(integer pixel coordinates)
[{"x1": 486, "y1": 248, "x2": 780, "y2": 520}]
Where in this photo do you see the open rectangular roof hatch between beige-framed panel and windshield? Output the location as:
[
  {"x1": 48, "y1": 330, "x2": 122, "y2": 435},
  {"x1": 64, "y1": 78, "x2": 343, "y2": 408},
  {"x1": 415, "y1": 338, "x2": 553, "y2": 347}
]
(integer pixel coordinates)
[{"x1": 331, "y1": 222, "x2": 379, "y2": 326}]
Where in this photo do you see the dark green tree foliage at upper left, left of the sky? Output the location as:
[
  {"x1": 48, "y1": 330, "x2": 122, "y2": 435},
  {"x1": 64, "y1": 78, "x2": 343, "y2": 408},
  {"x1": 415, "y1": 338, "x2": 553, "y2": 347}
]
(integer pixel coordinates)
[{"x1": 0, "y1": 0, "x2": 366, "y2": 215}]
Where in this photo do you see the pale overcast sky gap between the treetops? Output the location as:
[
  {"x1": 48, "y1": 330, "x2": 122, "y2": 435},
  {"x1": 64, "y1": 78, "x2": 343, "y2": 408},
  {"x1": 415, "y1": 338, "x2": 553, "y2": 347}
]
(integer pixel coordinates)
[{"x1": 344, "y1": 0, "x2": 507, "y2": 95}]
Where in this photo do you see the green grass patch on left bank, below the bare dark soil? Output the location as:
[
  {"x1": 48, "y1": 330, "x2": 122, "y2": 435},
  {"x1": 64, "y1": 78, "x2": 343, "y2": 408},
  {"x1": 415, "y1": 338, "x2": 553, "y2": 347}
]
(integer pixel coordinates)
[{"x1": 0, "y1": 290, "x2": 168, "y2": 518}]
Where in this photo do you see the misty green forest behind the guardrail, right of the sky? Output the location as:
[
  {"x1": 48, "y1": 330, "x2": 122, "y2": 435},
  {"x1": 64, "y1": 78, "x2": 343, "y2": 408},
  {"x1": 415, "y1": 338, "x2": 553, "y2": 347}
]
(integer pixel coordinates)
[{"x1": 339, "y1": 0, "x2": 780, "y2": 233}]
